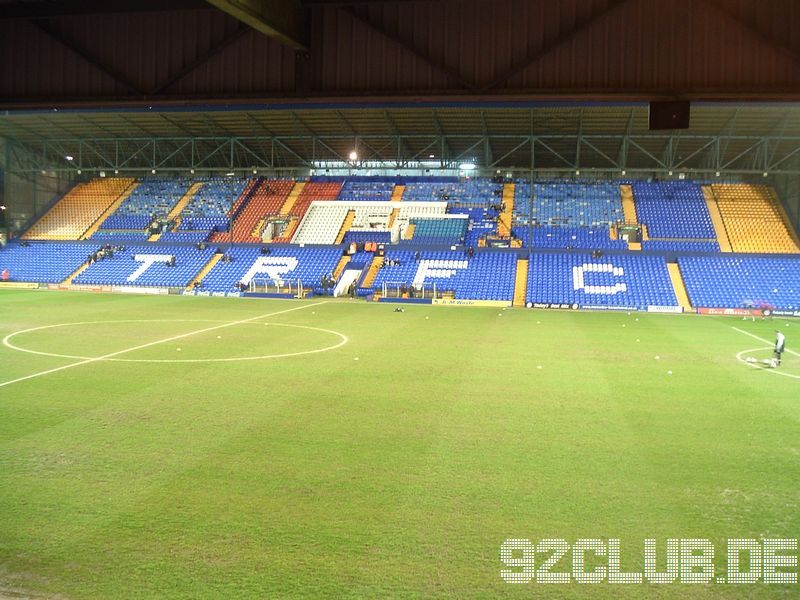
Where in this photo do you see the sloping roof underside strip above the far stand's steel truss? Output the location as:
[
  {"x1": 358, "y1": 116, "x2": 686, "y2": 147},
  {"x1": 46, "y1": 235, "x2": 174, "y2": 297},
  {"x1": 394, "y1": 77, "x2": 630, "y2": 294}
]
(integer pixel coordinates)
[{"x1": 0, "y1": 101, "x2": 800, "y2": 141}]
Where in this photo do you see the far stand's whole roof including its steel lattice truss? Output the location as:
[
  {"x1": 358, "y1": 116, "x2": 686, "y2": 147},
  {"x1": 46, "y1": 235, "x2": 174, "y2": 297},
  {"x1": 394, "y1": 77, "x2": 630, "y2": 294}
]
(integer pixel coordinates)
[{"x1": 0, "y1": 101, "x2": 800, "y2": 172}]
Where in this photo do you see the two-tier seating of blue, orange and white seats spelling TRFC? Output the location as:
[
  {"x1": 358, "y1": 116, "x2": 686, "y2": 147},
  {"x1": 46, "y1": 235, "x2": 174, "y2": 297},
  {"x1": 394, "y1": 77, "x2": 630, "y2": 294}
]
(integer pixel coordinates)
[{"x1": 0, "y1": 177, "x2": 800, "y2": 310}]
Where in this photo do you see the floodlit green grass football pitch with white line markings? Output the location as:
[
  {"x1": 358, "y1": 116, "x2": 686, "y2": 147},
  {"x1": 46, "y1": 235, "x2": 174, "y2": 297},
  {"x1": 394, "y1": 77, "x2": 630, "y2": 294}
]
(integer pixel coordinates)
[{"x1": 0, "y1": 291, "x2": 800, "y2": 599}]
